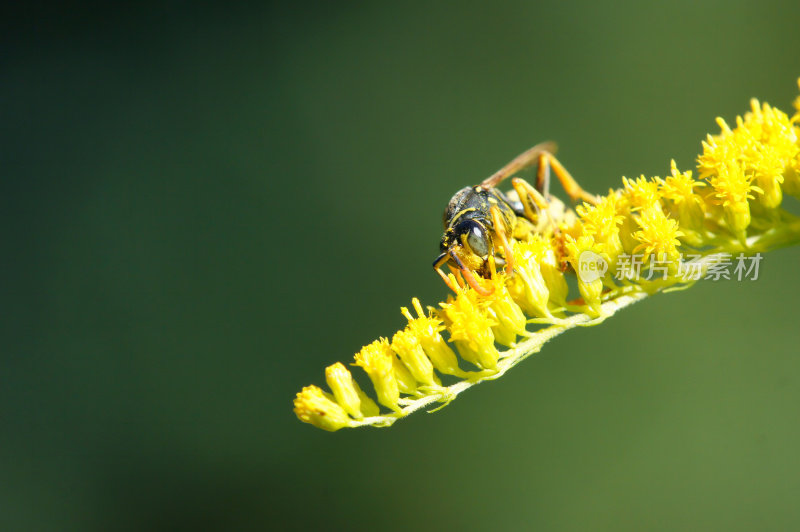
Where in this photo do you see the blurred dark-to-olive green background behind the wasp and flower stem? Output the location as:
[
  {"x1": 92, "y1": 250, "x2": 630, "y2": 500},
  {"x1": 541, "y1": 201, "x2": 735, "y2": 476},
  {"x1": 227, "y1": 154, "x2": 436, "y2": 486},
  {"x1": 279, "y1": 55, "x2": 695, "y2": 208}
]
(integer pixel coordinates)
[{"x1": 0, "y1": 0, "x2": 800, "y2": 531}]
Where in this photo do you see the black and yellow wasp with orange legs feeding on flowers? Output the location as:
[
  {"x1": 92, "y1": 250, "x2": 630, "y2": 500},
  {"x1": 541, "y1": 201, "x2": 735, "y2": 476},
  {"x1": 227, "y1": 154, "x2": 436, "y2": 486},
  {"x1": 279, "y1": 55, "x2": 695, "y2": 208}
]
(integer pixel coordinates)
[{"x1": 433, "y1": 142, "x2": 597, "y2": 295}]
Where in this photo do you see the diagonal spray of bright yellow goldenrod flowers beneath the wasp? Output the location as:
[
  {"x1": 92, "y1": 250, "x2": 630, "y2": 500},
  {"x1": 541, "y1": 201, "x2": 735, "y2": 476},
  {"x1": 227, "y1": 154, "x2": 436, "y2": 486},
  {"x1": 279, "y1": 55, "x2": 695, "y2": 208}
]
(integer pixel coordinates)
[{"x1": 294, "y1": 80, "x2": 800, "y2": 431}]
